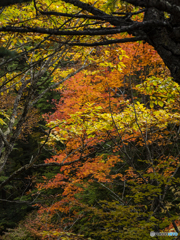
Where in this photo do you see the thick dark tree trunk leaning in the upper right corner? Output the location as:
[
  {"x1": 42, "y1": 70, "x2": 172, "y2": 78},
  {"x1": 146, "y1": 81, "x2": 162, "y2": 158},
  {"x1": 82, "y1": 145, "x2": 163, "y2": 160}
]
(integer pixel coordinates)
[{"x1": 119, "y1": 0, "x2": 180, "y2": 84}]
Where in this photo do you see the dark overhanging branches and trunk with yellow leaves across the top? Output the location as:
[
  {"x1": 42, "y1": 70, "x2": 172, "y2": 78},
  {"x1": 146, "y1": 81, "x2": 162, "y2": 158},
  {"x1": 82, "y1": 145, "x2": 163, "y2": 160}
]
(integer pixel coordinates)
[{"x1": 0, "y1": 0, "x2": 180, "y2": 82}]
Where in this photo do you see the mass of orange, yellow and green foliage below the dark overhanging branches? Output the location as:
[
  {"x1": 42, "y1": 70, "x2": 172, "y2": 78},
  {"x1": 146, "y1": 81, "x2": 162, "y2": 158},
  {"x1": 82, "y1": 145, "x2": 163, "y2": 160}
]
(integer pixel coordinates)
[{"x1": 10, "y1": 36, "x2": 177, "y2": 239}]
